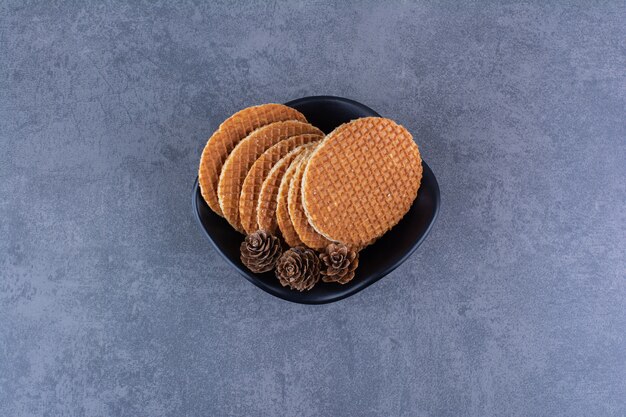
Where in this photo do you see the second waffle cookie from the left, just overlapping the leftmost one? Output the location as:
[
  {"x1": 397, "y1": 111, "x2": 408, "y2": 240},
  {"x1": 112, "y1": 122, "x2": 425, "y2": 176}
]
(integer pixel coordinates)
[{"x1": 217, "y1": 120, "x2": 323, "y2": 233}]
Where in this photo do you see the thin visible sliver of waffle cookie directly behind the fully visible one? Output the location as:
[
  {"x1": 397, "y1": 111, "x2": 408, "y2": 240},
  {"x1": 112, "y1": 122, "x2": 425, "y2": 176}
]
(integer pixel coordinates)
[{"x1": 287, "y1": 156, "x2": 330, "y2": 249}]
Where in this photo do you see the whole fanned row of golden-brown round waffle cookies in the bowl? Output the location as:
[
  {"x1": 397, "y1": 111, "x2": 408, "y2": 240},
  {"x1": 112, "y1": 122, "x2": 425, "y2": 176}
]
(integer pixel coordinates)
[{"x1": 199, "y1": 104, "x2": 422, "y2": 289}]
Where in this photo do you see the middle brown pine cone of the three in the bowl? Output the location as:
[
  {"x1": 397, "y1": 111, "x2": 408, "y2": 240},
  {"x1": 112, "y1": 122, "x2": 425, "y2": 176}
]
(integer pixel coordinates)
[{"x1": 276, "y1": 246, "x2": 320, "y2": 291}]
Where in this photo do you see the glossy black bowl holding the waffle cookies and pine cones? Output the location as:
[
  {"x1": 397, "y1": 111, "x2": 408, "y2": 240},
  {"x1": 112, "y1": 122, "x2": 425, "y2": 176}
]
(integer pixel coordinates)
[{"x1": 192, "y1": 96, "x2": 440, "y2": 304}]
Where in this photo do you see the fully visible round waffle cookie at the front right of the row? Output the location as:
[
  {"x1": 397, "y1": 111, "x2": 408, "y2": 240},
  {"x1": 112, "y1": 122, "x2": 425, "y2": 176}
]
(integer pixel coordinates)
[{"x1": 302, "y1": 117, "x2": 422, "y2": 247}]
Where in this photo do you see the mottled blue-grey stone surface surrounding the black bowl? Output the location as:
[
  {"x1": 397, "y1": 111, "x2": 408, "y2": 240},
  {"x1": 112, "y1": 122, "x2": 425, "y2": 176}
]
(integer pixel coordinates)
[{"x1": 0, "y1": 1, "x2": 626, "y2": 417}]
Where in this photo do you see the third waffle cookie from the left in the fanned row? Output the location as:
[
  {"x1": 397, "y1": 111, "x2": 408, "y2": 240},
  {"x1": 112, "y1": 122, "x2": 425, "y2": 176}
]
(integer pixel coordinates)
[{"x1": 239, "y1": 134, "x2": 322, "y2": 234}]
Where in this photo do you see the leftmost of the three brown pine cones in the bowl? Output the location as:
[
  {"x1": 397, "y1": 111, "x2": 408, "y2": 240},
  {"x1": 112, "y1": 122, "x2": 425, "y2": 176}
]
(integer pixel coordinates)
[{"x1": 240, "y1": 230, "x2": 283, "y2": 273}]
